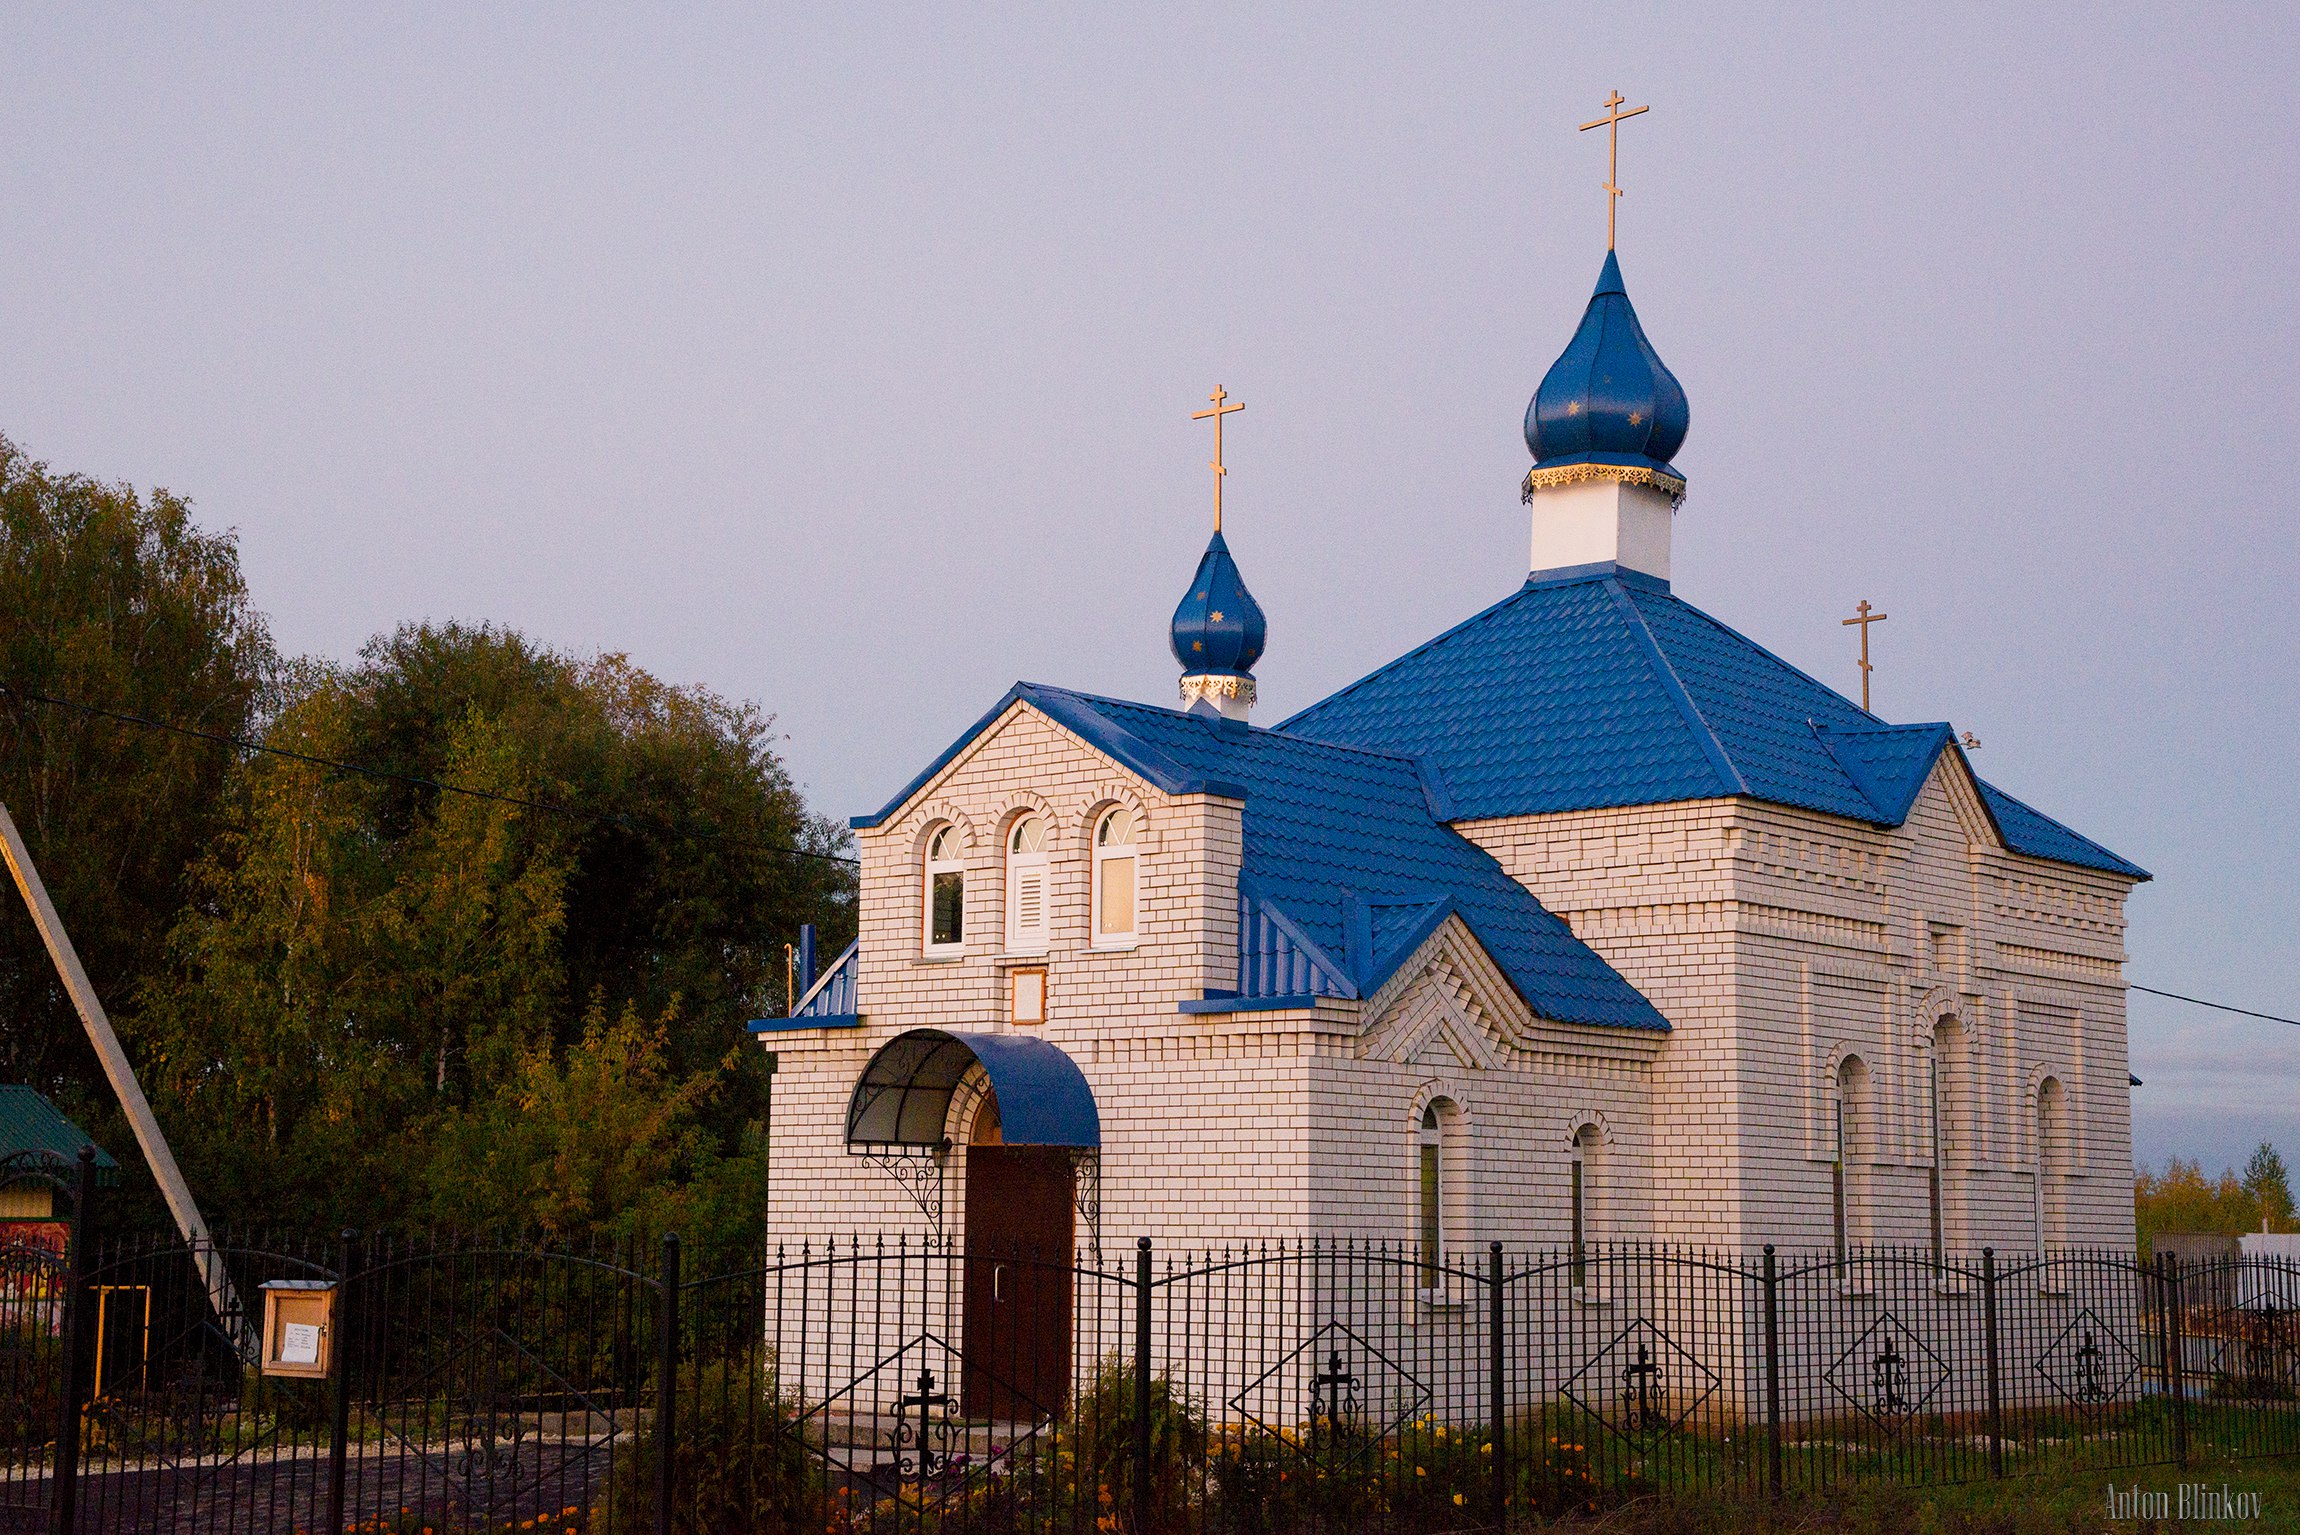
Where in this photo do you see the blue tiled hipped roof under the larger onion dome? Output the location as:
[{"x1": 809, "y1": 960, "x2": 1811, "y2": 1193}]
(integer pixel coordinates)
[{"x1": 1279, "y1": 566, "x2": 2148, "y2": 879}]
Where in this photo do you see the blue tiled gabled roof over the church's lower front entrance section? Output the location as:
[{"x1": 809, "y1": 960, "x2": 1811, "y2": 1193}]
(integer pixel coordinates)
[{"x1": 1024, "y1": 686, "x2": 1670, "y2": 1029}]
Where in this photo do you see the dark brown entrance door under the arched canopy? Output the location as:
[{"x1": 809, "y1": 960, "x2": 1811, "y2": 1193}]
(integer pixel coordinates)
[{"x1": 959, "y1": 1146, "x2": 1074, "y2": 1422}]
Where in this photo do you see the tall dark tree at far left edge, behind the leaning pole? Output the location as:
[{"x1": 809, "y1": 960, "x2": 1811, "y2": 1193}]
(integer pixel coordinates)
[{"x1": 0, "y1": 437, "x2": 274, "y2": 1118}]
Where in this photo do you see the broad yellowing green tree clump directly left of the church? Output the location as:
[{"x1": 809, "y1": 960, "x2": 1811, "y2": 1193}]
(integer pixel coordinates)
[{"x1": 136, "y1": 624, "x2": 853, "y2": 1231}]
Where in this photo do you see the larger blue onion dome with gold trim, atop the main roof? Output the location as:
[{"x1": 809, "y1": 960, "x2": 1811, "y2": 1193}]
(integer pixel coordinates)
[{"x1": 1525, "y1": 251, "x2": 1691, "y2": 497}]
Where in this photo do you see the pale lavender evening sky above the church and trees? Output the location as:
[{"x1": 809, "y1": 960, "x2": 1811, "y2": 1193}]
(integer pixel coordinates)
[{"x1": 0, "y1": 0, "x2": 2300, "y2": 1167}]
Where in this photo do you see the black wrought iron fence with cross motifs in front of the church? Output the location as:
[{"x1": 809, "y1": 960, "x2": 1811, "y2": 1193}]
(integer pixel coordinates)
[{"x1": 0, "y1": 1236, "x2": 2300, "y2": 1535}]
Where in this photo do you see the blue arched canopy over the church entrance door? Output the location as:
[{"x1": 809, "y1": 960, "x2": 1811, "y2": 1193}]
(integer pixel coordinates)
[{"x1": 846, "y1": 1029, "x2": 1102, "y2": 1151}]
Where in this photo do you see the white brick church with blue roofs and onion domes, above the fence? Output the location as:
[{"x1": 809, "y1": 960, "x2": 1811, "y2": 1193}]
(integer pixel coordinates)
[{"x1": 754, "y1": 253, "x2": 2148, "y2": 1257}]
